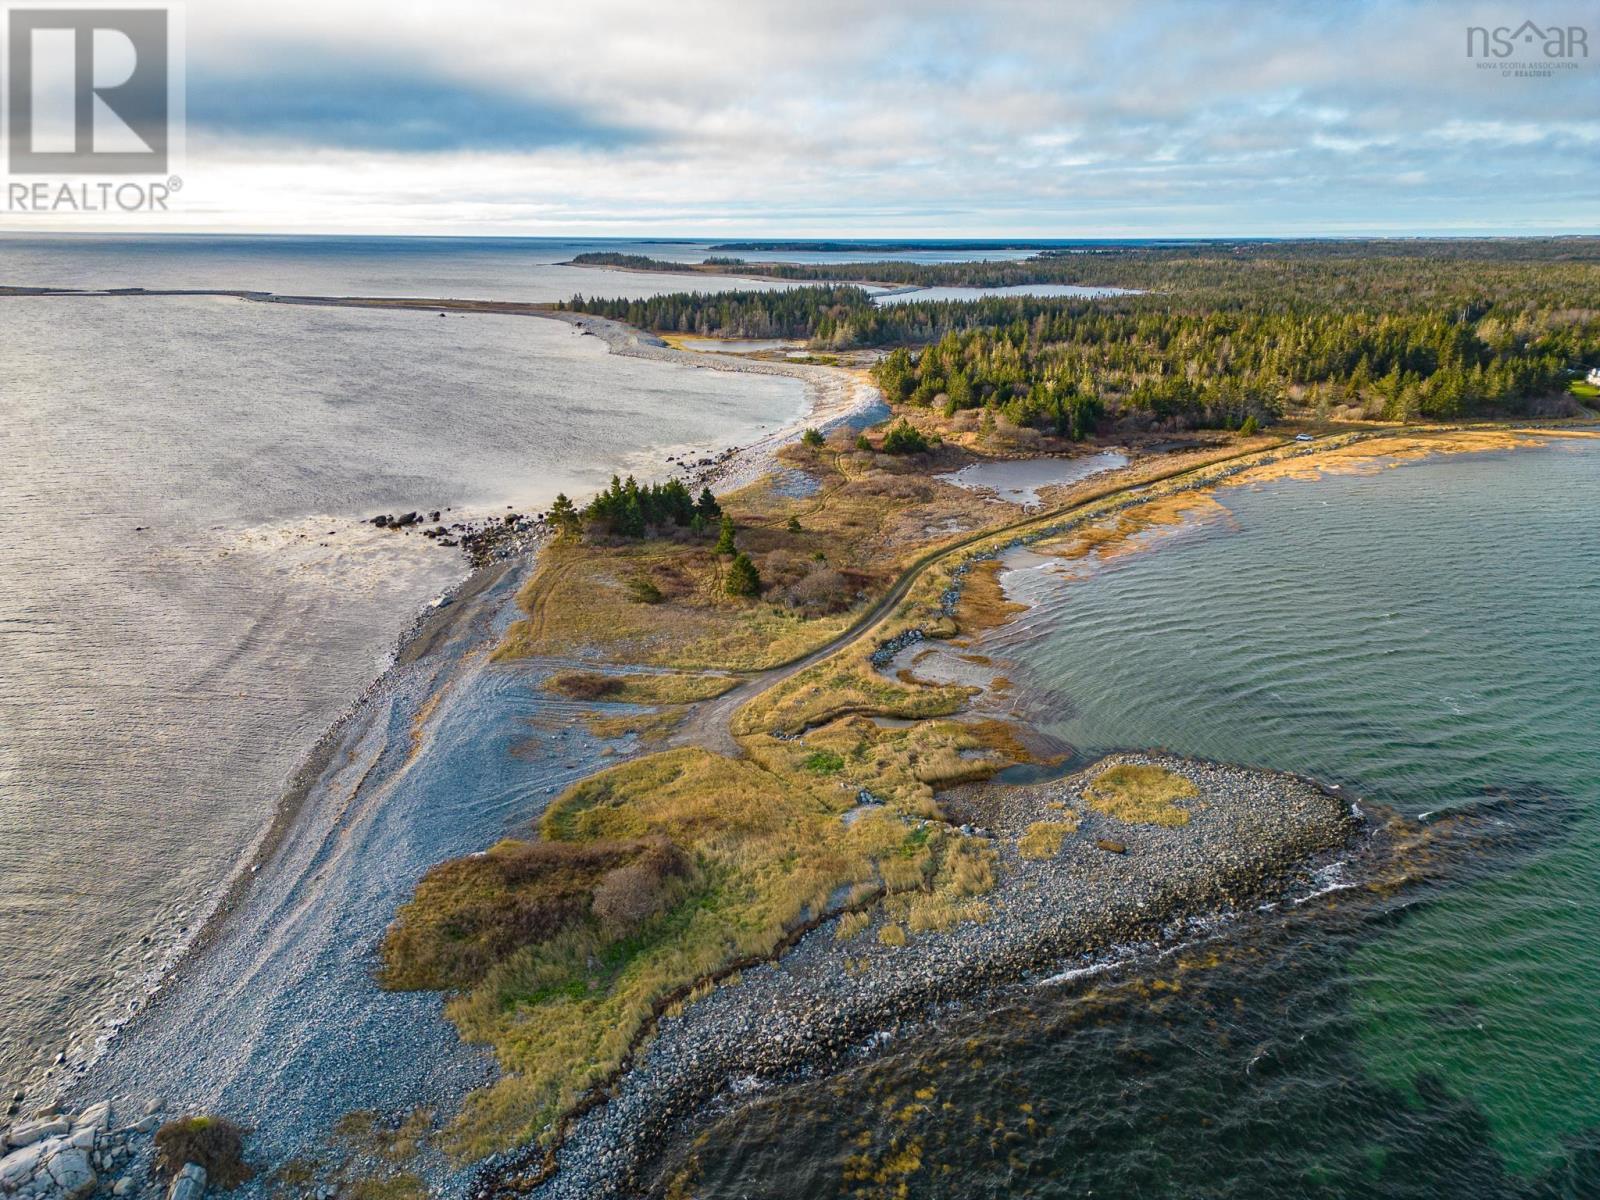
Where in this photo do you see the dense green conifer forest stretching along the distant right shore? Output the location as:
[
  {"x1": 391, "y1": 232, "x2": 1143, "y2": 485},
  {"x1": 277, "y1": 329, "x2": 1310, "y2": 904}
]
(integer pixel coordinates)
[{"x1": 568, "y1": 238, "x2": 1600, "y2": 437}]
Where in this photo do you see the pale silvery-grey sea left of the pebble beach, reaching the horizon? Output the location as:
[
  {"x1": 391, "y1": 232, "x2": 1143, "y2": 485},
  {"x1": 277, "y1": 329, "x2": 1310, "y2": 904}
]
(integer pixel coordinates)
[{"x1": 0, "y1": 246, "x2": 805, "y2": 1094}]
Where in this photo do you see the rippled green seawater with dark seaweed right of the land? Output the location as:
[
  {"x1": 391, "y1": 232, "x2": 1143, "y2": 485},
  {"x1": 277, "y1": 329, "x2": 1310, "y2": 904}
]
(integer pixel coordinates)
[{"x1": 678, "y1": 442, "x2": 1600, "y2": 1200}]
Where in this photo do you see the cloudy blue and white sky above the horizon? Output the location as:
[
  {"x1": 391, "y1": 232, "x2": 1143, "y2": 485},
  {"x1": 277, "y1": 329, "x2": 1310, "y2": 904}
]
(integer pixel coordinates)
[{"x1": 0, "y1": 0, "x2": 1600, "y2": 237}]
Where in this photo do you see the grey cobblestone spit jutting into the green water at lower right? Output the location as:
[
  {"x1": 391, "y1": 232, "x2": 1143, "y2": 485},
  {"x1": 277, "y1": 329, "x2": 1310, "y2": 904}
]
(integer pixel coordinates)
[{"x1": 474, "y1": 754, "x2": 1363, "y2": 1200}]
